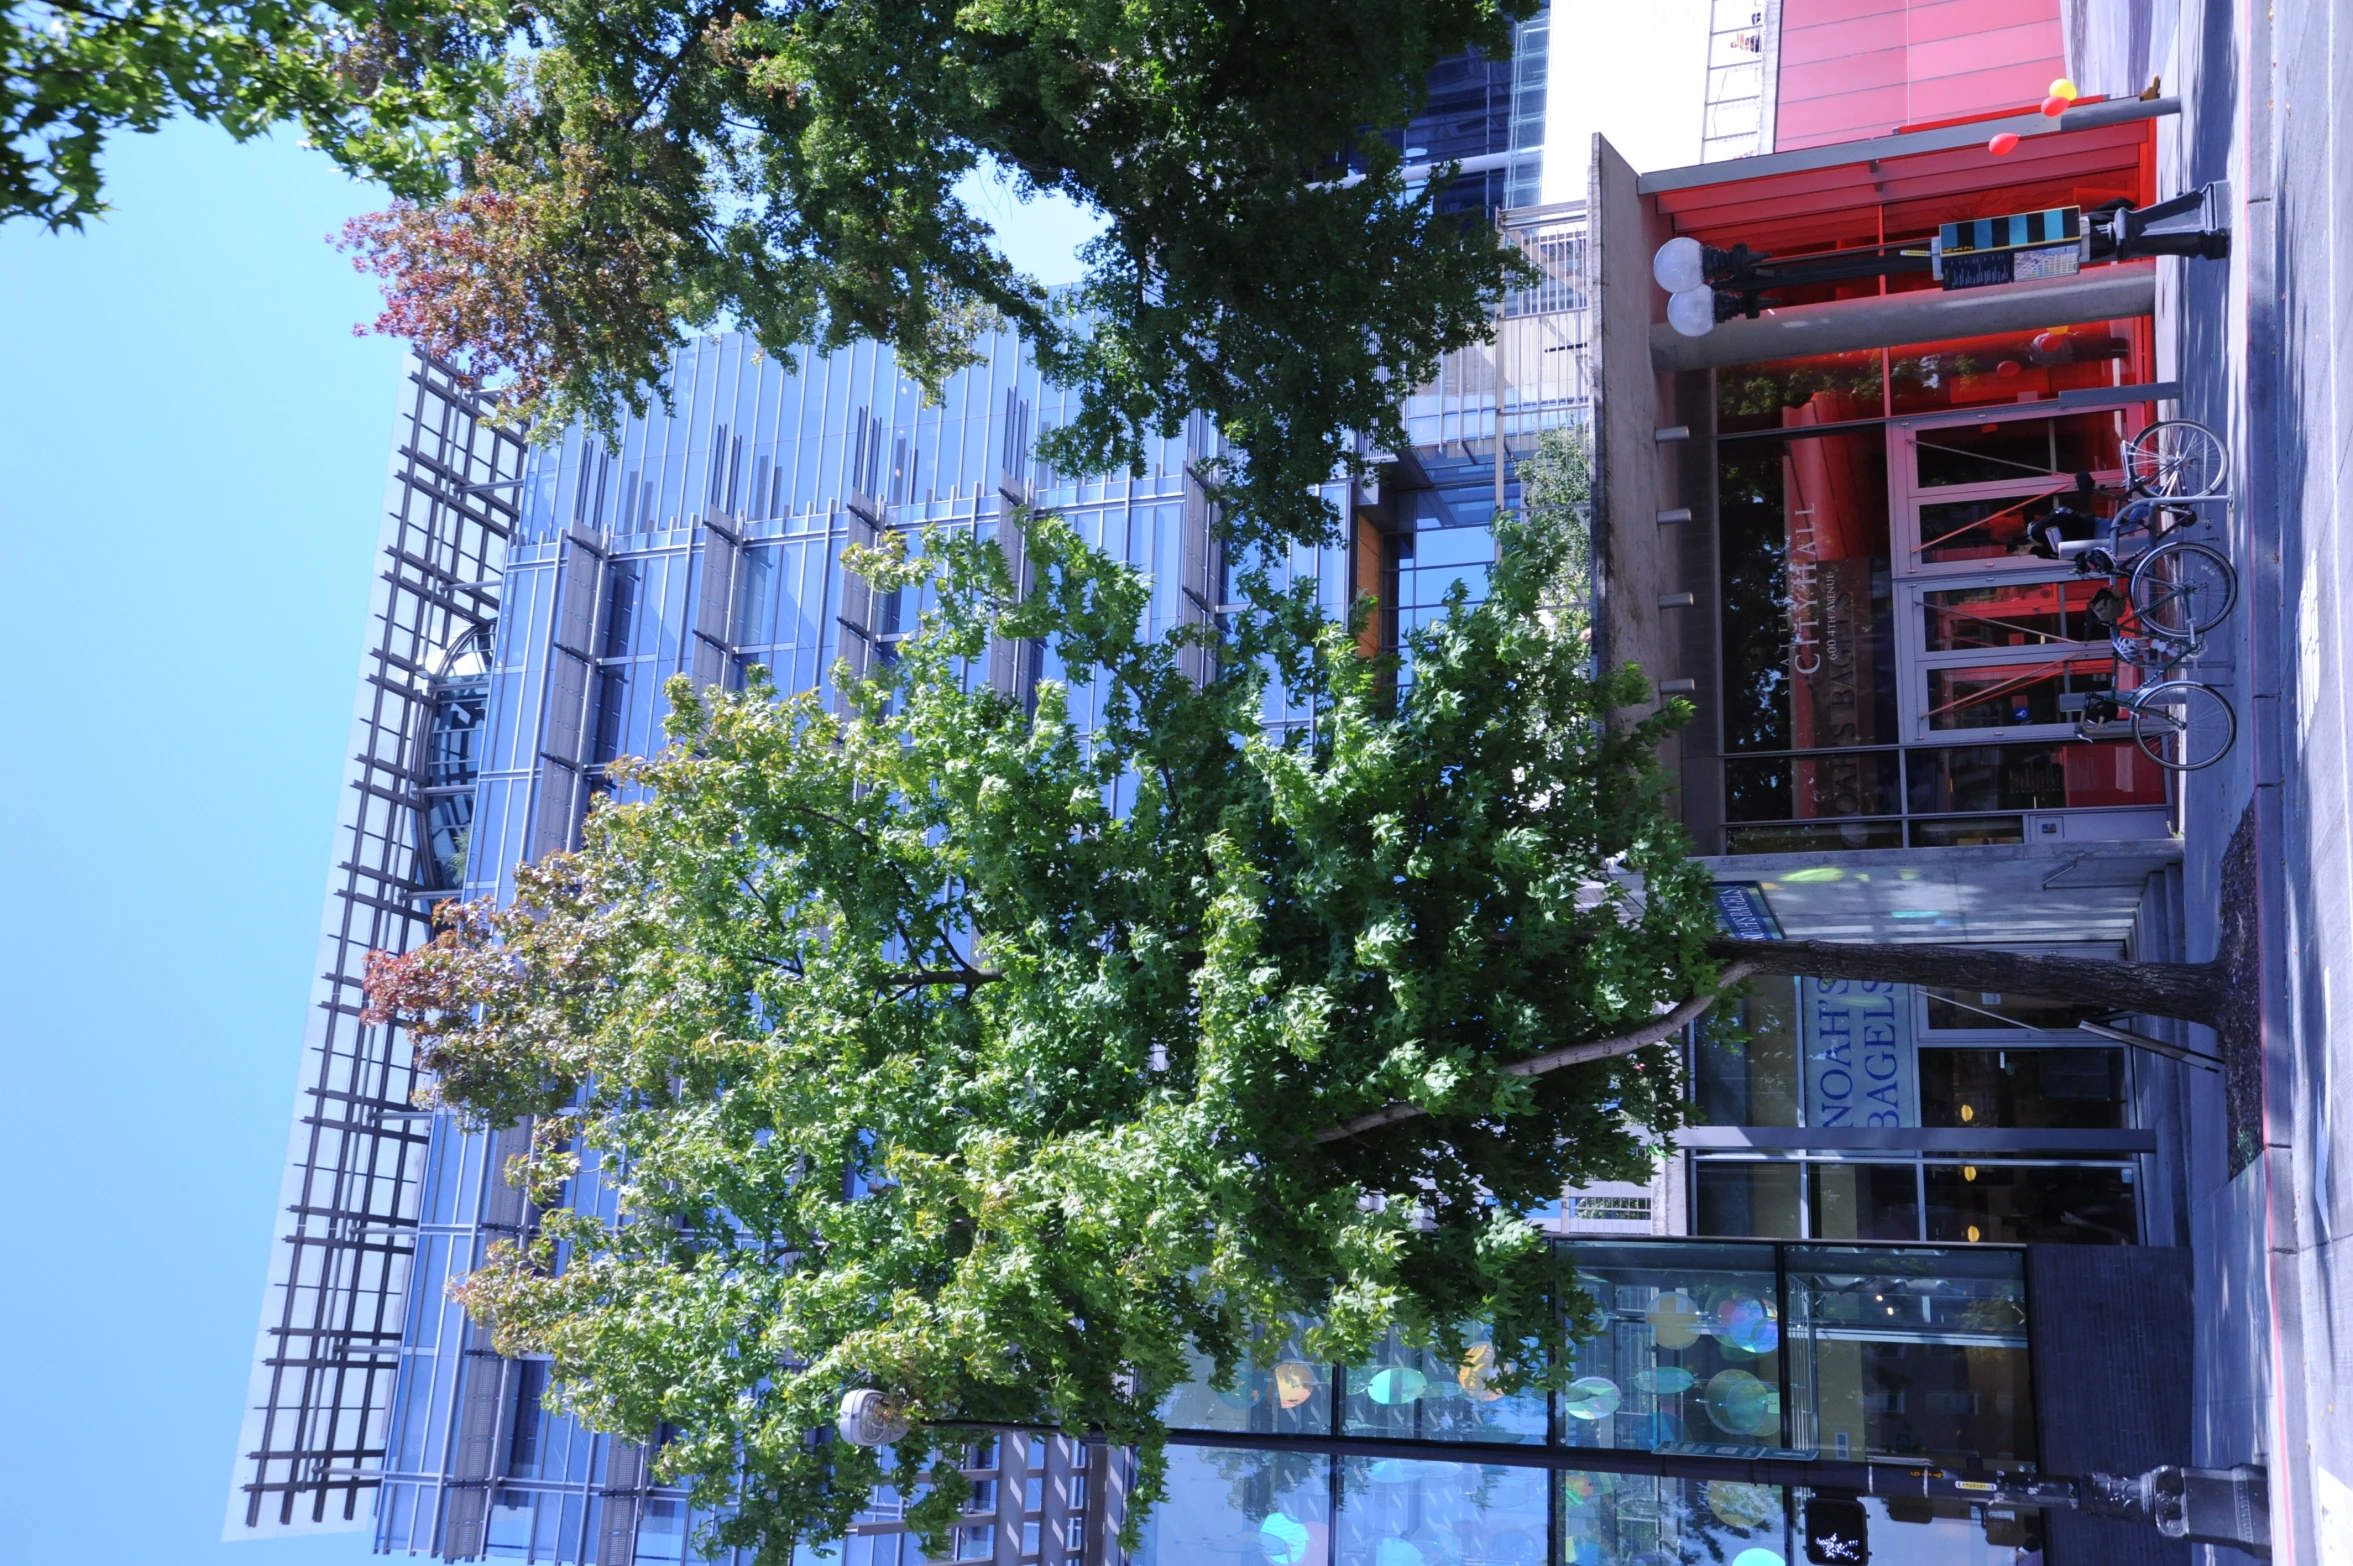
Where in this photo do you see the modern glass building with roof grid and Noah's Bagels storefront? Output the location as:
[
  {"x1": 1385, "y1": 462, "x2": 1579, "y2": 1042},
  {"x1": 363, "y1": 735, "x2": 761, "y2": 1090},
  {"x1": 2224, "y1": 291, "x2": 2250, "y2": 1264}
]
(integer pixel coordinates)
[{"x1": 228, "y1": 14, "x2": 2179, "y2": 1566}]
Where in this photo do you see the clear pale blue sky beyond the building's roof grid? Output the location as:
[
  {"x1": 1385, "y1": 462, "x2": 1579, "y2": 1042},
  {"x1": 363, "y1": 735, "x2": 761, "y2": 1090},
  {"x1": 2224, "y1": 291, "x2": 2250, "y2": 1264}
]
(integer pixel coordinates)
[{"x1": 0, "y1": 127, "x2": 1087, "y2": 1566}]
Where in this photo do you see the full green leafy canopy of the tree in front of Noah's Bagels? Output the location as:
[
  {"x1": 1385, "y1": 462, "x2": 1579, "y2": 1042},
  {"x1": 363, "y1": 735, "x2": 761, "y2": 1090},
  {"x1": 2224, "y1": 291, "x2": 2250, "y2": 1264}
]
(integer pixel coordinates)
[{"x1": 372, "y1": 442, "x2": 1713, "y2": 1559}]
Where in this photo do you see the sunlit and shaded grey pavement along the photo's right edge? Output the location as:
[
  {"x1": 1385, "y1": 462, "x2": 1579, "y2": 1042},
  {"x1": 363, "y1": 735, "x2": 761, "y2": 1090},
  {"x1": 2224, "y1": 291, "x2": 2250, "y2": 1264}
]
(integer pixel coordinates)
[{"x1": 2164, "y1": 0, "x2": 2353, "y2": 1566}]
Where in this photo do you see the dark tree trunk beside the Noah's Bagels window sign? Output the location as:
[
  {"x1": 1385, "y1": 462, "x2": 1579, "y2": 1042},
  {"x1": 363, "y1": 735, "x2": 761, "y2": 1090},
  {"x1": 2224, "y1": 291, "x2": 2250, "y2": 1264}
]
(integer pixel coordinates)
[{"x1": 1708, "y1": 936, "x2": 2224, "y2": 1028}]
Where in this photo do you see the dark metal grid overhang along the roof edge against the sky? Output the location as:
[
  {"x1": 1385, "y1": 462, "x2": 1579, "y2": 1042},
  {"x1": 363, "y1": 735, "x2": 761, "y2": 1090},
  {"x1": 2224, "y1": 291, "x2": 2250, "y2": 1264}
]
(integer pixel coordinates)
[{"x1": 224, "y1": 360, "x2": 525, "y2": 1538}]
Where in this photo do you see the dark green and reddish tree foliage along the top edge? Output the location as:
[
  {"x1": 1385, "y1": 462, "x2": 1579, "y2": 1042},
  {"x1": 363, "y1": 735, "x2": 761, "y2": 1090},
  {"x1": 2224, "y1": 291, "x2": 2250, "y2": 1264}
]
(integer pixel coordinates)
[{"x1": 18, "y1": 0, "x2": 1537, "y2": 538}]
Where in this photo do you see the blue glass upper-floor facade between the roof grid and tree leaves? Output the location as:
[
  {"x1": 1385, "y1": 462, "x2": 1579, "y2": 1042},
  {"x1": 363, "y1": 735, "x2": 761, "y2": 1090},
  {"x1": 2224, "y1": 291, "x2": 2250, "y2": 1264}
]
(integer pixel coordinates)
[{"x1": 233, "y1": 143, "x2": 1586, "y2": 1566}]
